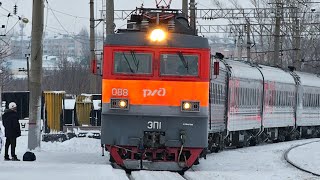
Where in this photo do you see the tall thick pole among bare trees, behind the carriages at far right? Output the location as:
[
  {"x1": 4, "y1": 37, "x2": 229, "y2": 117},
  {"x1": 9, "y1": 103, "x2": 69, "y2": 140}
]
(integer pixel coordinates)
[{"x1": 273, "y1": 0, "x2": 283, "y2": 66}]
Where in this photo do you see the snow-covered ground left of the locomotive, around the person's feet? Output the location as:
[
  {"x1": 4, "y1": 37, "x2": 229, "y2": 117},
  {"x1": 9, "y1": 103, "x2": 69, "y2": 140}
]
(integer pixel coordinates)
[{"x1": 0, "y1": 136, "x2": 128, "y2": 180}]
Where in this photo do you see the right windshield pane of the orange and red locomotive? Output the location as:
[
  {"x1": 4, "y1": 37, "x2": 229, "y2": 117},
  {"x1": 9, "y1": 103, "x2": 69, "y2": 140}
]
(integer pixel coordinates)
[{"x1": 160, "y1": 52, "x2": 199, "y2": 76}]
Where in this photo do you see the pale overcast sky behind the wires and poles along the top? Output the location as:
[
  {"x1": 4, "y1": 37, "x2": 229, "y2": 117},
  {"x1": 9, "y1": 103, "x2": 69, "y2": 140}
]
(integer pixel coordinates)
[{"x1": 0, "y1": 0, "x2": 235, "y2": 34}]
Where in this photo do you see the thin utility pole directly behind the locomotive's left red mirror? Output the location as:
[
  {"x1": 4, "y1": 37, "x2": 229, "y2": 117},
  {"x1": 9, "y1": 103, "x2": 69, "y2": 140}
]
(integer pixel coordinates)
[{"x1": 88, "y1": 0, "x2": 98, "y2": 92}]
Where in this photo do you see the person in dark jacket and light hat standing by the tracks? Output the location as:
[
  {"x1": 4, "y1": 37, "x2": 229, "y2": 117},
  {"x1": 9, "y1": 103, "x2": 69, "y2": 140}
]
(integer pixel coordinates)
[{"x1": 2, "y1": 102, "x2": 21, "y2": 161}]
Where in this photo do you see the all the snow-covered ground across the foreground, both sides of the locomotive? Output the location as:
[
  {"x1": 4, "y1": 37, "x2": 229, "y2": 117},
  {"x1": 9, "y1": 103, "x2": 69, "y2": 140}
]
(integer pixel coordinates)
[{"x1": 0, "y1": 123, "x2": 320, "y2": 180}]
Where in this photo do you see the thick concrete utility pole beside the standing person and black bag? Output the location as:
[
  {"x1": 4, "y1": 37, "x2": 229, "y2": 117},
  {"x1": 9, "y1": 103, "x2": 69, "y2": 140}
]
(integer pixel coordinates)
[{"x1": 28, "y1": 0, "x2": 44, "y2": 150}]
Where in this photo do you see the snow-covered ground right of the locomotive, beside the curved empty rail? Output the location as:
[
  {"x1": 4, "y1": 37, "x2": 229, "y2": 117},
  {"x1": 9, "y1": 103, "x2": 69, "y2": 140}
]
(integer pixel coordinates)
[{"x1": 185, "y1": 139, "x2": 320, "y2": 180}]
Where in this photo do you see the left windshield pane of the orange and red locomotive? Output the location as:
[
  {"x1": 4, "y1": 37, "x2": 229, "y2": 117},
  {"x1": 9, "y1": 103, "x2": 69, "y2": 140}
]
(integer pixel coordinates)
[{"x1": 113, "y1": 51, "x2": 152, "y2": 74}]
